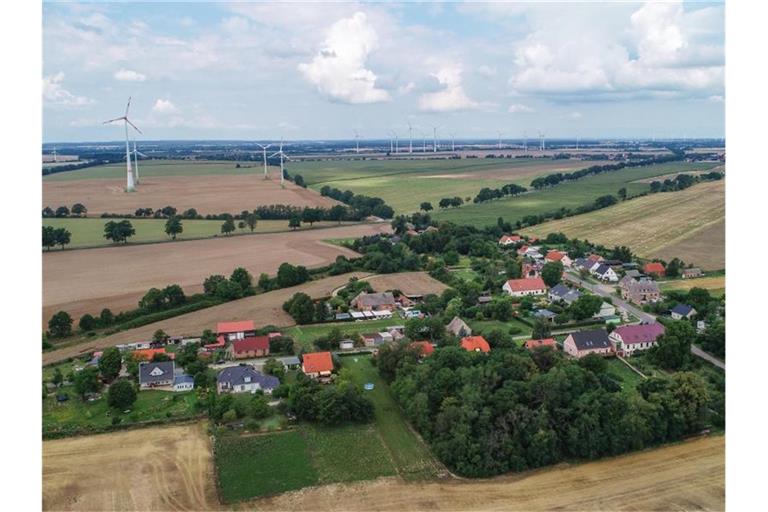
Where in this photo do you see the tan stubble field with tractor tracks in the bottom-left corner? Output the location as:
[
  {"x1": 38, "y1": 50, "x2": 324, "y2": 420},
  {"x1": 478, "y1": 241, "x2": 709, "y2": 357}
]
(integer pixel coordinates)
[{"x1": 43, "y1": 423, "x2": 219, "y2": 511}]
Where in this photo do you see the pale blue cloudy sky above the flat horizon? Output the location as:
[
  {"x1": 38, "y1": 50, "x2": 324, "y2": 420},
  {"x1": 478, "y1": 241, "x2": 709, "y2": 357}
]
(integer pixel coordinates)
[{"x1": 42, "y1": 2, "x2": 725, "y2": 142}]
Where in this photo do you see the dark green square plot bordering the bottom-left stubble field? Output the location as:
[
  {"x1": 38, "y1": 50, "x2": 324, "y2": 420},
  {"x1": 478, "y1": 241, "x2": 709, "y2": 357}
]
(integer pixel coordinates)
[{"x1": 214, "y1": 430, "x2": 319, "y2": 503}]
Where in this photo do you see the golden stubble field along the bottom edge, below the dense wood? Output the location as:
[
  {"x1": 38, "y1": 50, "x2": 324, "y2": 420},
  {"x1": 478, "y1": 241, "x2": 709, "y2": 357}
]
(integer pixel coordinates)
[{"x1": 249, "y1": 436, "x2": 725, "y2": 512}]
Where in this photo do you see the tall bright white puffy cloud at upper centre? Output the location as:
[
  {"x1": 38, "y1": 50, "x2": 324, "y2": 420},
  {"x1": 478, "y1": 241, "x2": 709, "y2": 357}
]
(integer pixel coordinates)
[{"x1": 298, "y1": 12, "x2": 390, "y2": 103}]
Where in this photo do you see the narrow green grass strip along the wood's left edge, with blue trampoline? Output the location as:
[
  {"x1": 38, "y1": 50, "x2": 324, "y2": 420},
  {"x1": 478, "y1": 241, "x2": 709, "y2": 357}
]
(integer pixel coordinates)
[{"x1": 342, "y1": 356, "x2": 440, "y2": 480}]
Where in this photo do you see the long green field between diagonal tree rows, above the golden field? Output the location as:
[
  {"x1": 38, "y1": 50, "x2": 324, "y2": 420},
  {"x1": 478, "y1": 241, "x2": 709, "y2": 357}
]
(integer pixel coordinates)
[{"x1": 432, "y1": 162, "x2": 714, "y2": 228}]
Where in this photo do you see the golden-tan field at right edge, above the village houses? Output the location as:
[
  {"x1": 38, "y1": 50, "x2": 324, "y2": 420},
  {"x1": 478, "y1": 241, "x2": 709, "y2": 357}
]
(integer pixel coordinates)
[{"x1": 522, "y1": 180, "x2": 725, "y2": 270}]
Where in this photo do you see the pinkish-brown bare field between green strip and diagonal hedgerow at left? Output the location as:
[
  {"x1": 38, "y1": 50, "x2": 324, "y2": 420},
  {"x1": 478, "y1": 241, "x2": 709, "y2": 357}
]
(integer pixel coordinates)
[{"x1": 43, "y1": 223, "x2": 390, "y2": 323}]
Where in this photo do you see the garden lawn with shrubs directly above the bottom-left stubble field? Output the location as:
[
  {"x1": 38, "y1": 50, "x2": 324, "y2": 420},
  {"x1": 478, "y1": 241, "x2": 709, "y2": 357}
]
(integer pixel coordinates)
[{"x1": 43, "y1": 386, "x2": 197, "y2": 433}]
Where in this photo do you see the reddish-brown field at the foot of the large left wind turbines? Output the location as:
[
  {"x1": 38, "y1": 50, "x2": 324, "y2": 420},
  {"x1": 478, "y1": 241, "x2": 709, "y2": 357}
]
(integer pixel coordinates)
[{"x1": 43, "y1": 171, "x2": 339, "y2": 216}]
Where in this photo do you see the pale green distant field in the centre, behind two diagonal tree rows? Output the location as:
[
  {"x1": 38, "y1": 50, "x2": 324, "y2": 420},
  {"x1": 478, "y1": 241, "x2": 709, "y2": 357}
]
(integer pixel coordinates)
[{"x1": 291, "y1": 158, "x2": 608, "y2": 213}]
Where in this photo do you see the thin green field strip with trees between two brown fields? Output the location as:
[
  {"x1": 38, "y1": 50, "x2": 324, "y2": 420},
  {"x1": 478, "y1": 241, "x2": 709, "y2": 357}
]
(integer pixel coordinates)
[{"x1": 43, "y1": 217, "x2": 352, "y2": 251}]
